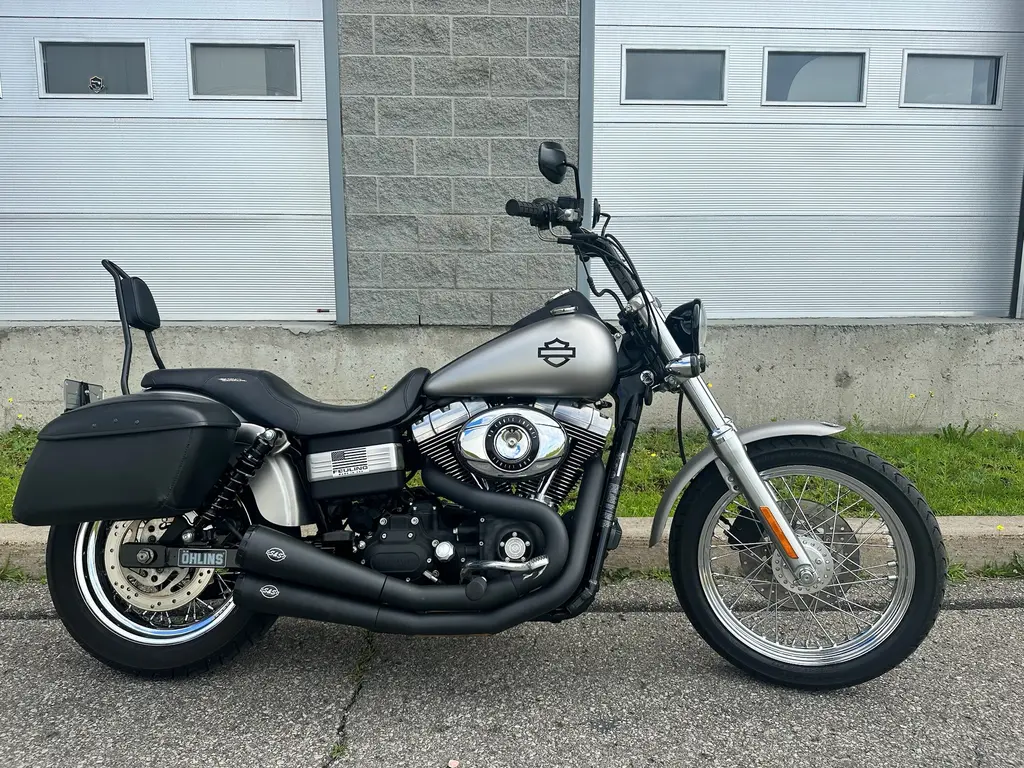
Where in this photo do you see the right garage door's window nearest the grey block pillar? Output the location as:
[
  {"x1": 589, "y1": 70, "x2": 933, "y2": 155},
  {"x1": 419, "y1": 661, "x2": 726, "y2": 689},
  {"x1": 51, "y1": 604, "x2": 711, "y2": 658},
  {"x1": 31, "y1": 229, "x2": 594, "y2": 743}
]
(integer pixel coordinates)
[{"x1": 622, "y1": 47, "x2": 726, "y2": 104}]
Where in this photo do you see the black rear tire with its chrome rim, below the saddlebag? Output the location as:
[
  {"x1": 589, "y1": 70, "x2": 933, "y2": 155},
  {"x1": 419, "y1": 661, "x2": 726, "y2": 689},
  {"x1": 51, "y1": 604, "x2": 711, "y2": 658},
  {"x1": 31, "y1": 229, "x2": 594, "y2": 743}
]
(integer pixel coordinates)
[{"x1": 46, "y1": 523, "x2": 274, "y2": 678}]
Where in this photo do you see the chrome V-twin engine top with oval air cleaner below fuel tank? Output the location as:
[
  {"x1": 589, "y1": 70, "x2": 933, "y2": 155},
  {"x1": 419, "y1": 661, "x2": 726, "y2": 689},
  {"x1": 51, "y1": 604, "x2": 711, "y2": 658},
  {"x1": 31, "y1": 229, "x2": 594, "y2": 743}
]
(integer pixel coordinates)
[{"x1": 413, "y1": 399, "x2": 612, "y2": 507}]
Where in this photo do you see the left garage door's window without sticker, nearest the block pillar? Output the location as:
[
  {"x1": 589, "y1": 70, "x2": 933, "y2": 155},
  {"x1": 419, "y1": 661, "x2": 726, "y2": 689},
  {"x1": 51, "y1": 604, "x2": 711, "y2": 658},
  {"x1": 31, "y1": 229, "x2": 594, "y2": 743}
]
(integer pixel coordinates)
[{"x1": 188, "y1": 42, "x2": 301, "y2": 101}]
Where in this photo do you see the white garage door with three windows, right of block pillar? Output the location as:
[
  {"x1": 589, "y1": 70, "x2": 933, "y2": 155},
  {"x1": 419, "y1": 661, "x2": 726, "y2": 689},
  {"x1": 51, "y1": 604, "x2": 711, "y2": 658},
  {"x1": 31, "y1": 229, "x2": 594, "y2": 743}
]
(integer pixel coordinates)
[{"x1": 593, "y1": 0, "x2": 1024, "y2": 317}]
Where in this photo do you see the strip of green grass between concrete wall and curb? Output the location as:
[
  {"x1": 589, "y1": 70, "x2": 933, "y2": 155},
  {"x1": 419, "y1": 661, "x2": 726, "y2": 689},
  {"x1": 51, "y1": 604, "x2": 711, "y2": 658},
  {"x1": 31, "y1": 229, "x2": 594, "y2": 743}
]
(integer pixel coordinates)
[{"x1": 0, "y1": 423, "x2": 1024, "y2": 522}]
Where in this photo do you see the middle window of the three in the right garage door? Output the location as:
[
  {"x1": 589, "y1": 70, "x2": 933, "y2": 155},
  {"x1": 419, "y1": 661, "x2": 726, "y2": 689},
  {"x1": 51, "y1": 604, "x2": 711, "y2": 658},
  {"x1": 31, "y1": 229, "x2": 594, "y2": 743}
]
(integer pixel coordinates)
[{"x1": 762, "y1": 50, "x2": 867, "y2": 106}]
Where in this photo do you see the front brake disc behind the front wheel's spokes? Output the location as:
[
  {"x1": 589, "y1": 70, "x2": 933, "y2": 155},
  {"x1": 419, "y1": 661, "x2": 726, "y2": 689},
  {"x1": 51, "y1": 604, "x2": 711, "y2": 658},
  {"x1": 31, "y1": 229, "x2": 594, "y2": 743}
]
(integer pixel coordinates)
[{"x1": 727, "y1": 499, "x2": 860, "y2": 600}]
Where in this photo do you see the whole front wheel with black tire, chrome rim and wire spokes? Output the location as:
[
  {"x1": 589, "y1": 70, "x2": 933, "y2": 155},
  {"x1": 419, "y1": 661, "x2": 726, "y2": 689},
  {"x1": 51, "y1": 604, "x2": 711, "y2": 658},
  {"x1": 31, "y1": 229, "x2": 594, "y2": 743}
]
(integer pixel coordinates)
[{"x1": 669, "y1": 437, "x2": 946, "y2": 688}]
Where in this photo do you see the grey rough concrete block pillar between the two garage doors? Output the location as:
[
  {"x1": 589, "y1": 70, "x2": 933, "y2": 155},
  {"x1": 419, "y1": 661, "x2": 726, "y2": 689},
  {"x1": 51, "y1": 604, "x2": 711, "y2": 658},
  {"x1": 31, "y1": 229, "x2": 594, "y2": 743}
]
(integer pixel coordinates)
[{"x1": 338, "y1": 0, "x2": 580, "y2": 326}]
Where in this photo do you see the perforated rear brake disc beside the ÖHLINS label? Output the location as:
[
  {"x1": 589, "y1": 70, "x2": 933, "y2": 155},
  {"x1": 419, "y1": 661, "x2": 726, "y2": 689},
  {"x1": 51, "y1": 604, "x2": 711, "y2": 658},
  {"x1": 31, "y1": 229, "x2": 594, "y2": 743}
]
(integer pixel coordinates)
[{"x1": 103, "y1": 518, "x2": 214, "y2": 611}]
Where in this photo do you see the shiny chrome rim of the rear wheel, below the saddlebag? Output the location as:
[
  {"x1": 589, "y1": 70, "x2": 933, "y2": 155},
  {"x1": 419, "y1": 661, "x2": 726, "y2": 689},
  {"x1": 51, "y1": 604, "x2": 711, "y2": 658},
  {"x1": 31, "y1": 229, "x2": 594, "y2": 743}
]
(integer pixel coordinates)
[{"x1": 74, "y1": 520, "x2": 236, "y2": 645}]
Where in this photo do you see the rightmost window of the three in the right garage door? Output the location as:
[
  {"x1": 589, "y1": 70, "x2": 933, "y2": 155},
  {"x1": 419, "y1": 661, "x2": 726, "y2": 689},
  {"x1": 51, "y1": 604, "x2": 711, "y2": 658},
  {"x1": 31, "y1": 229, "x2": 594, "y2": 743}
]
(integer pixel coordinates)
[{"x1": 900, "y1": 51, "x2": 1002, "y2": 110}]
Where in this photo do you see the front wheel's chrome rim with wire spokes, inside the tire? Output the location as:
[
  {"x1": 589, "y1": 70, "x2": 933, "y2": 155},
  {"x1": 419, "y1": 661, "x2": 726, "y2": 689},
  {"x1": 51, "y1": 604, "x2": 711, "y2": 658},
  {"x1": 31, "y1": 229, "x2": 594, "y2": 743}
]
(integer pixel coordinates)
[{"x1": 697, "y1": 465, "x2": 914, "y2": 667}]
